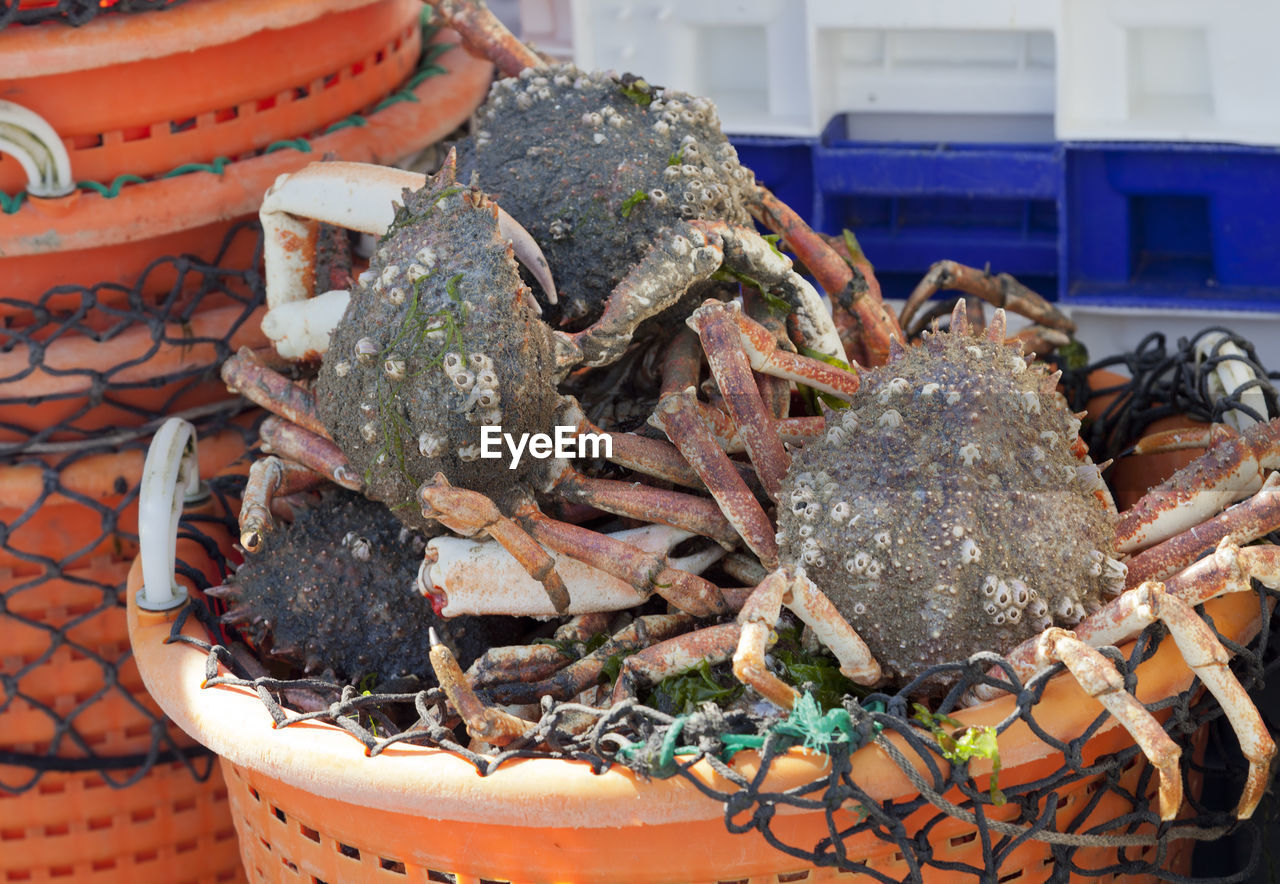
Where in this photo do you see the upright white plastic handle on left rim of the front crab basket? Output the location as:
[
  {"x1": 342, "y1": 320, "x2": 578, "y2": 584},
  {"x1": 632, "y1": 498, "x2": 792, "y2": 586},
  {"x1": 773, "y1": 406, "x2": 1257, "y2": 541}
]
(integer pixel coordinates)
[{"x1": 138, "y1": 417, "x2": 200, "y2": 610}]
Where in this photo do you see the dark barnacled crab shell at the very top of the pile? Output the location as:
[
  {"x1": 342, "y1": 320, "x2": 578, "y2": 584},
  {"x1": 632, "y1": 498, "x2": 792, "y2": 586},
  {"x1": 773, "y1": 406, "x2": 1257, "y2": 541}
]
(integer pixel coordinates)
[{"x1": 458, "y1": 64, "x2": 755, "y2": 325}]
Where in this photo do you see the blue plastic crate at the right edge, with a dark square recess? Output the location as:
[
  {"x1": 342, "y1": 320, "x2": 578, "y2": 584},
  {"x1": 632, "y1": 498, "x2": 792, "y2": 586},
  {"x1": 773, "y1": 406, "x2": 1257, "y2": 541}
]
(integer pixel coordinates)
[{"x1": 1060, "y1": 142, "x2": 1280, "y2": 310}]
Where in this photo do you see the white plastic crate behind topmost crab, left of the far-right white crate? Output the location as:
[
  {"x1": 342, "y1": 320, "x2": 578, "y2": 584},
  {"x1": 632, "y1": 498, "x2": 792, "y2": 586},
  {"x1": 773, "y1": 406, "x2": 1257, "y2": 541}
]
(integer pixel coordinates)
[{"x1": 542, "y1": 0, "x2": 1057, "y2": 141}]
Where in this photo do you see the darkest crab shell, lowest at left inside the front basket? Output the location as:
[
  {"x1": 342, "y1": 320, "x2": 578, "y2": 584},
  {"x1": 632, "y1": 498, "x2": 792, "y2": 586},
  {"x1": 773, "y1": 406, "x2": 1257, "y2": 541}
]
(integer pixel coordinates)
[{"x1": 221, "y1": 489, "x2": 508, "y2": 683}]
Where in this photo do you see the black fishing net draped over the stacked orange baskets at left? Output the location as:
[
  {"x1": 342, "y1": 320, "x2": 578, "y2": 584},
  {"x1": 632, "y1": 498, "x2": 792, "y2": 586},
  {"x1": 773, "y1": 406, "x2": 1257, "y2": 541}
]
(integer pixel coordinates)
[{"x1": 0, "y1": 223, "x2": 264, "y2": 792}]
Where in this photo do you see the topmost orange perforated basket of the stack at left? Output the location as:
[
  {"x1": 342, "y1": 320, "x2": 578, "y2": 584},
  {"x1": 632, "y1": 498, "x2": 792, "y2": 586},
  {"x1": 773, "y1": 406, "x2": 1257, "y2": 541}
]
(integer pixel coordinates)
[{"x1": 0, "y1": 0, "x2": 421, "y2": 193}]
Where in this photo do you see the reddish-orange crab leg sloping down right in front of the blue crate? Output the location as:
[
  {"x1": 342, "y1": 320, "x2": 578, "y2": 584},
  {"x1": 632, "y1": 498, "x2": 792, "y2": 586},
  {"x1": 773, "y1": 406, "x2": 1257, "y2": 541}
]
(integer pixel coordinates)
[{"x1": 748, "y1": 184, "x2": 902, "y2": 365}]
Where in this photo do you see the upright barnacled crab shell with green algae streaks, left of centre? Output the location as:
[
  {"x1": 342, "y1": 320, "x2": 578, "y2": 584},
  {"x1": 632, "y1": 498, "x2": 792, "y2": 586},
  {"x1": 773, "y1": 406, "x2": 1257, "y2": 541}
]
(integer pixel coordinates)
[{"x1": 316, "y1": 166, "x2": 563, "y2": 528}]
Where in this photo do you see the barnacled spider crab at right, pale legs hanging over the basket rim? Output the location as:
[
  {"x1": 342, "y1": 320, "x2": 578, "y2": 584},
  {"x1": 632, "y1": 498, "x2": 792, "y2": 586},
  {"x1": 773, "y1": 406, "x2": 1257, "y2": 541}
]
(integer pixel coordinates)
[{"x1": 431, "y1": 302, "x2": 1280, "y2": 819}]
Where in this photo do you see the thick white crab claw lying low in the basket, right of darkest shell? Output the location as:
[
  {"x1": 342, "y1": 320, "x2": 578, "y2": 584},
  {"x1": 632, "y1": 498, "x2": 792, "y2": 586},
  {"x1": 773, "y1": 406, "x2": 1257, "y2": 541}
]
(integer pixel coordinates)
[{"x1": 417, "y1": 525, "x2": 724, "y2": 617}]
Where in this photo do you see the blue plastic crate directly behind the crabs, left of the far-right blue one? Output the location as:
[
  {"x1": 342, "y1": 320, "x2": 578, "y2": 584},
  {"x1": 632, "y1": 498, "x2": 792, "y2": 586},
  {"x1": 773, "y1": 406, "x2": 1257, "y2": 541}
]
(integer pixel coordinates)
[{"x1": 733, "y1": 125, "x2": 1062, "y2": 304}]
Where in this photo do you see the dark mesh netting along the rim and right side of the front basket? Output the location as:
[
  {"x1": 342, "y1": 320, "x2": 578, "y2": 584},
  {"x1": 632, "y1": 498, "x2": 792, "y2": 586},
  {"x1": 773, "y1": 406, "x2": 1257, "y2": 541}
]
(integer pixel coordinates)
[{"x1": 172, "y1": 327, "x2": 1280, "y2": 881}]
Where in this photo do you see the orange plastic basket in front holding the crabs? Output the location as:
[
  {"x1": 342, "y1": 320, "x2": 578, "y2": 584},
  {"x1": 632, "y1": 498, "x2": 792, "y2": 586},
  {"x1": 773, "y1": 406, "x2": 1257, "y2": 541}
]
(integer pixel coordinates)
[{"x1": 128, "y1": 417, "x2": 1260, "y2": 884}]
